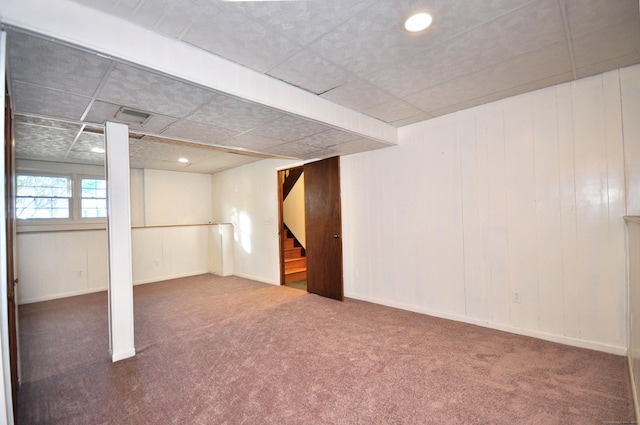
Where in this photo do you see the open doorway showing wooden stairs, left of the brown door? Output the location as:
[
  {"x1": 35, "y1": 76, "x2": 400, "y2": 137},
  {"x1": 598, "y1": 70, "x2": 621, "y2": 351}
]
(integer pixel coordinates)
[{"x1": 278, "y1": 167, "x2": 307, "y2": 291}]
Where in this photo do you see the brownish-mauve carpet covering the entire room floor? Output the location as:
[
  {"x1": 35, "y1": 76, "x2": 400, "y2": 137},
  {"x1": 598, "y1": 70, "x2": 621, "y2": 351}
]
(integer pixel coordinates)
[{"x1": 18, "y1": 275, "x2": 634, "y2": 425}]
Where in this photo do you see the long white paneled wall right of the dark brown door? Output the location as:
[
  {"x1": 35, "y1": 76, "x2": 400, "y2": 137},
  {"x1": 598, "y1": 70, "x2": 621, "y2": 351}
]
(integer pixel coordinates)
[{"x1": 341, "y1": 67, "x2": 640, "y2": 353}]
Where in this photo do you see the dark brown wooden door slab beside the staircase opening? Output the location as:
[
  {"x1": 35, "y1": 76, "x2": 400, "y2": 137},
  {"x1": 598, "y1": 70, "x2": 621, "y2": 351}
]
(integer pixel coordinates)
[{"x1": 304, "y1": 157, "x2": 343, "y2": 301}]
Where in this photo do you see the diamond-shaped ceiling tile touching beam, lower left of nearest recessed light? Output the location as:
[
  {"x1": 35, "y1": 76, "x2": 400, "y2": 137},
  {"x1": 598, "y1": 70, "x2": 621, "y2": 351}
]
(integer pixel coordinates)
[{"x1": 267, "y1": 50, "x2": 349, "y2": 94}]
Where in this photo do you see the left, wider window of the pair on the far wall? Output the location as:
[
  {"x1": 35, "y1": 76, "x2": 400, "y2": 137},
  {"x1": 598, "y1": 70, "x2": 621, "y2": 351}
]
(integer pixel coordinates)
[{"x1": 16, "y1": 175, "x2": 72, "y2": 220}]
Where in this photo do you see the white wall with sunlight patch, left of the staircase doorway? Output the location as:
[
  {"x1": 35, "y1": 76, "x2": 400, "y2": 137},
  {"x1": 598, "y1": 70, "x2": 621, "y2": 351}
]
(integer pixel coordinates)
[{"x1": 213, "y1": 159, "x2": 299, "y2": 285}]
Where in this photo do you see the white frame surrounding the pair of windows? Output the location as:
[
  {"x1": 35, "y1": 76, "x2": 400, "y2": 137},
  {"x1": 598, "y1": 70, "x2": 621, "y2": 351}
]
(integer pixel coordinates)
[{"x1": 15, "y1": 170, "x2": 108, "y2": 227}]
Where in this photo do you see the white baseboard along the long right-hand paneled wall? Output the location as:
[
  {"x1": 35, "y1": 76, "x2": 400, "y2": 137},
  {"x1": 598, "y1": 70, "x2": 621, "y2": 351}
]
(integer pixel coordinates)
[{"x1": 345, "y1": 293, "x2": 627, "y2": 356}]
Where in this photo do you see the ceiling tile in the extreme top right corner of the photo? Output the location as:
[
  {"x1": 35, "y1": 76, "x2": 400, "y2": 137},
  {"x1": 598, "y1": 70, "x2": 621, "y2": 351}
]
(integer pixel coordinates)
[{"x1": 564, "y1": 0, "x2": 639, "y2": 38}]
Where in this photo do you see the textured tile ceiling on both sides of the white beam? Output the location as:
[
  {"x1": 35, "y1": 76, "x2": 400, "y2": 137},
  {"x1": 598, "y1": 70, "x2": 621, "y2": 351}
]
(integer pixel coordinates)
[{"x1": 3, "y1": 0, "x2": 640, "y2": 172}]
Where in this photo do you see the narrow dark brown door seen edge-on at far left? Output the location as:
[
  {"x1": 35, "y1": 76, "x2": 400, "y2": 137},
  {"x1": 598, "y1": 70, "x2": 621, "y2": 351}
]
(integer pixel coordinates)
[{"x1": 4, "y1": 96, "x2": 18, "y2": 416}]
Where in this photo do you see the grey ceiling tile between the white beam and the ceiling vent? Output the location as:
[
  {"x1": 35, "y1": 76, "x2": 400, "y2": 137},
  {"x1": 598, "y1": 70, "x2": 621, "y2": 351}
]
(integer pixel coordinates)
[{"x1": 97, "y1": 63, "x2": 212, "y2": 118}]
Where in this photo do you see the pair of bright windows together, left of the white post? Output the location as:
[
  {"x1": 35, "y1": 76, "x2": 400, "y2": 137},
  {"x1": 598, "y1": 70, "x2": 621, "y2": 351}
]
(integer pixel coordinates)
[{"x1": 16, "y1": 174, "x2": 107, "y2": 222}]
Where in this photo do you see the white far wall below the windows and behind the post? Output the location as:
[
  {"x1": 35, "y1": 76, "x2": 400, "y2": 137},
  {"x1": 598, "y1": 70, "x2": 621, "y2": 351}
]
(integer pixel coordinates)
[{"x1": 17, "y1": 166, "x2": 212, "y2": 304}]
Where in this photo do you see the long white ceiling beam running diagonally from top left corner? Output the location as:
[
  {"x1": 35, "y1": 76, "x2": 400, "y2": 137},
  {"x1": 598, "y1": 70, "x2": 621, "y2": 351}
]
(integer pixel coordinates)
[{"x1": 0, "y1": 0, "x2": 397, "y2": 145}]
